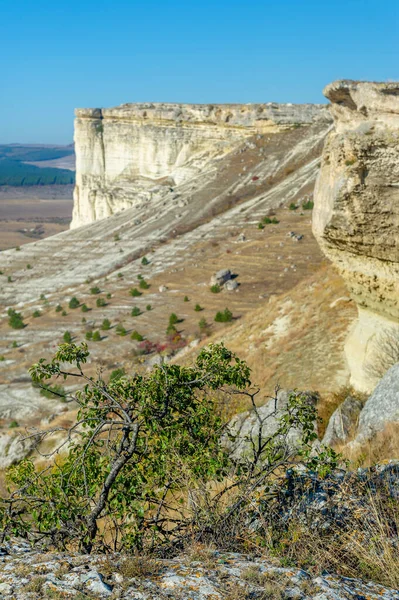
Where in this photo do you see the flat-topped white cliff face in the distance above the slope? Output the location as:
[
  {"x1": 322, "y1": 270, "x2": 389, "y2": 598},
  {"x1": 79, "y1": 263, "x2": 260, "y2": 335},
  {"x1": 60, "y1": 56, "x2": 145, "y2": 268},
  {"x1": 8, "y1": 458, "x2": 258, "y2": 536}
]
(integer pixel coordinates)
[{"x1": 71, "y1": 103, "x2": 329, "y2": 228}]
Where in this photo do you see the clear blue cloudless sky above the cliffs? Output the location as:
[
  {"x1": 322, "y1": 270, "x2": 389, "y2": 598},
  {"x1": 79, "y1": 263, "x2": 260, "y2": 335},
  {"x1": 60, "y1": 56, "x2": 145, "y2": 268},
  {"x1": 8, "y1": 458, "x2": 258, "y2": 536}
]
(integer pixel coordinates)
[{"x1": 0, "y1": 0, "x2": 399, "y2": 143}]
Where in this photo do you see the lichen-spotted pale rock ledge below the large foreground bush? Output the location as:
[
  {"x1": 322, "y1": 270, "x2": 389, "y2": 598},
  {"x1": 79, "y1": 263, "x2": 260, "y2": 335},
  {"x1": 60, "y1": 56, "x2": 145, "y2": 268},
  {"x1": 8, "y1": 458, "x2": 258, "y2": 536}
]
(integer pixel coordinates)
[{"x1": 0, "y1": 544, "x2": 399, "y2": 600}]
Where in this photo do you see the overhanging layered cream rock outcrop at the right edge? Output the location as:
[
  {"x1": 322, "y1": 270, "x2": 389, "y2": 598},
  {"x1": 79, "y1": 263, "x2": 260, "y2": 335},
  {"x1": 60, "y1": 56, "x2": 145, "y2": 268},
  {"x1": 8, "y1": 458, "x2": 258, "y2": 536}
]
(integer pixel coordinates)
[{"x1": 313, "y1": 81, "x2": 399, "y2": 391}]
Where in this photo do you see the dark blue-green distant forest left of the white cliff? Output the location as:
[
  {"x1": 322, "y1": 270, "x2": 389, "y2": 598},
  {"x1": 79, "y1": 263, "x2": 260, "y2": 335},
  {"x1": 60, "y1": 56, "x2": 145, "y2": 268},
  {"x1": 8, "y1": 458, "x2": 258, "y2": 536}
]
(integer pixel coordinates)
[{"x1": 0, "y1": 144, "x2": 75, "y2": 187}]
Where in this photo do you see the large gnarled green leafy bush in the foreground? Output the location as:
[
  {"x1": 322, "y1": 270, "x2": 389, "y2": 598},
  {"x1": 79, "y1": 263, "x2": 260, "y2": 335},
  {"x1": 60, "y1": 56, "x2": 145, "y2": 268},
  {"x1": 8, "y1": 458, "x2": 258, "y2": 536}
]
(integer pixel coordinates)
[{"x1": 0, "y1": 344, "x2": 337, "y2": 553}]
